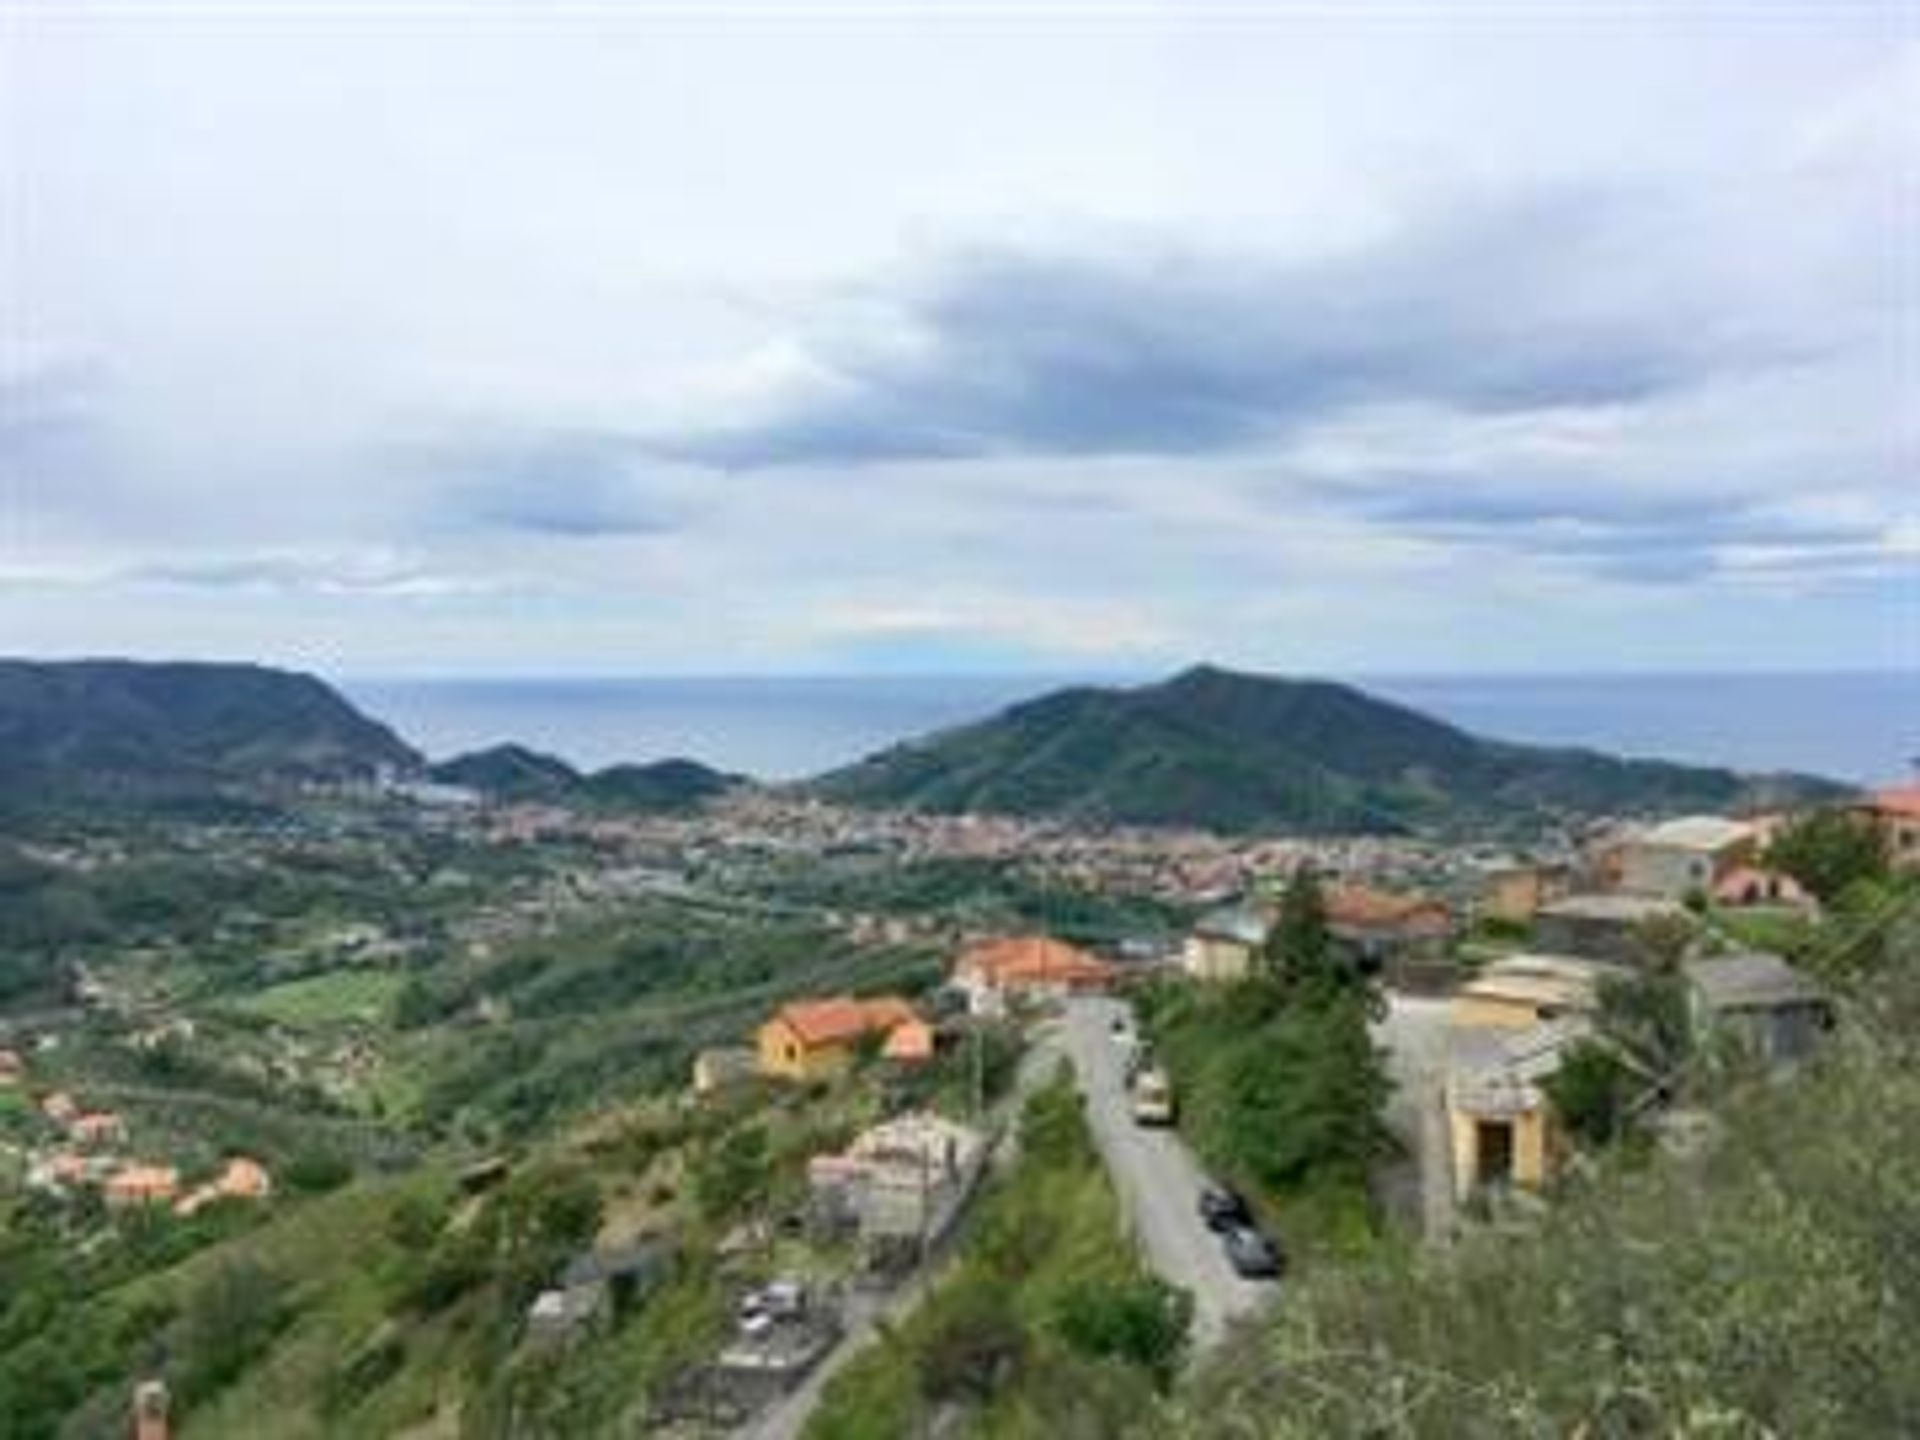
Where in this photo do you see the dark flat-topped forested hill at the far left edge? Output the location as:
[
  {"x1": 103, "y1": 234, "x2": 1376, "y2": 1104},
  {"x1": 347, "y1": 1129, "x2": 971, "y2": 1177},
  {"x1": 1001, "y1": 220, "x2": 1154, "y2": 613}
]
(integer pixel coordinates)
[{"x1": 0, "y1": 660, "x2": 420, "y2": 799}]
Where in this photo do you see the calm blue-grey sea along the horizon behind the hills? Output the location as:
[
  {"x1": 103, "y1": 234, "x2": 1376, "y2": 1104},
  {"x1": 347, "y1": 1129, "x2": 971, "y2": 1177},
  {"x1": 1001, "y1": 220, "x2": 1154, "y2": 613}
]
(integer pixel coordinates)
[{"x1": 338, "y1": 672, "x2": 1920, "y2": 783}]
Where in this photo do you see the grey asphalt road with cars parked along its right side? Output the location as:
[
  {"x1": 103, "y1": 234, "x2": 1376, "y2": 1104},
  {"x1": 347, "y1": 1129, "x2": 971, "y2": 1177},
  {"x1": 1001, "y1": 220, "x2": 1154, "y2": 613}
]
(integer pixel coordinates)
[{"x1": 1062, "y1": 996, "x2": 1284, "y2": 1350}]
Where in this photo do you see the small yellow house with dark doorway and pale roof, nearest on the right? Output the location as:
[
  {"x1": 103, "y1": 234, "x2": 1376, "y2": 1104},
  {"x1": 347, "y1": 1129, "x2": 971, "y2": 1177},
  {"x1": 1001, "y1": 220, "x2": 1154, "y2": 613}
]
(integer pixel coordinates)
[{"x1": 1446, "y1": 1016, "x2": 1592, "y2": 1200}]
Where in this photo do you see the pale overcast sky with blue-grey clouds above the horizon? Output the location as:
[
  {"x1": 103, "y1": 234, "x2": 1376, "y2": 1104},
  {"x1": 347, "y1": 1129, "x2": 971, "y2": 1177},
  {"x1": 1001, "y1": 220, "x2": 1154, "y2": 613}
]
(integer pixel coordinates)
[{"x1": 0, "y1": 0, "x2": 1920, "y2": 676}]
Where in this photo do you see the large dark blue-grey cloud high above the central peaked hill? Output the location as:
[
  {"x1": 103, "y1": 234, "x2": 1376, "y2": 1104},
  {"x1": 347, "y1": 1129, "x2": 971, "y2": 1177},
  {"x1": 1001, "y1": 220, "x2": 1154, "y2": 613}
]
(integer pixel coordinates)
[{"x1": 659, "y1": 190, "x2": 1793, "y2": 468}]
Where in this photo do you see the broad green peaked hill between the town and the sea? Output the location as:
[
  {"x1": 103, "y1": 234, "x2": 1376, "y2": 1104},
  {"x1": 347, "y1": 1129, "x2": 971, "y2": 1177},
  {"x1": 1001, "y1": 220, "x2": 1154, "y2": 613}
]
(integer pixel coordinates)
[{"x1": 814, "y1": 666, "x2": 1839, "y2": 831}]
